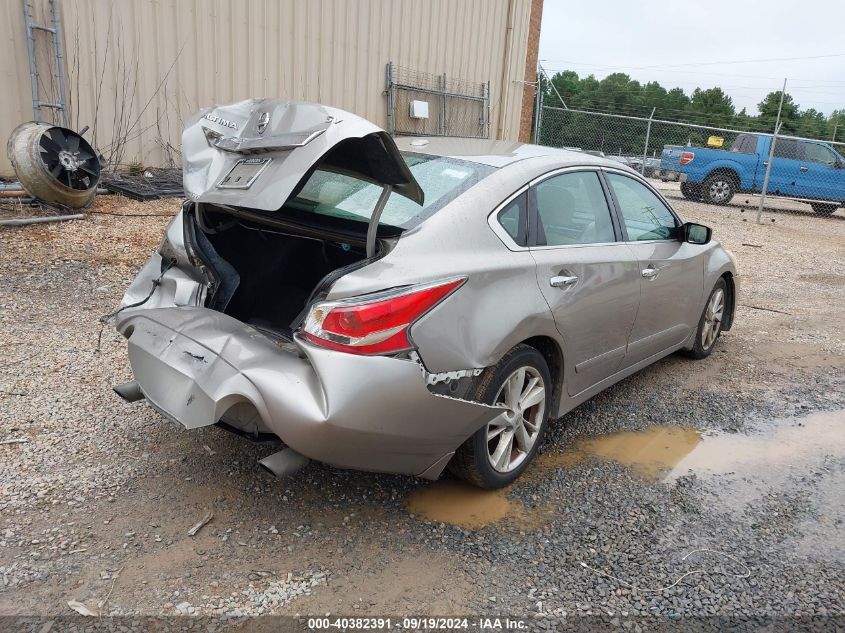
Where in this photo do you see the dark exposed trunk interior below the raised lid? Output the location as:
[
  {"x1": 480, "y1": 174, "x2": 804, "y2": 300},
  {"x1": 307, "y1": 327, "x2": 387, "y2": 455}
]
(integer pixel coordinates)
[{"x1": 196, "y1": 206, "x2": 365, "y2": 339}]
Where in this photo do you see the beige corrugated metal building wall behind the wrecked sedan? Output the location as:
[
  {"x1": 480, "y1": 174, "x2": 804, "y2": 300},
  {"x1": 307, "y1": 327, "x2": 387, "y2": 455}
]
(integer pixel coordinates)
[{"x1": 0, "y1": 0, "x2": 542, "y2": 176}]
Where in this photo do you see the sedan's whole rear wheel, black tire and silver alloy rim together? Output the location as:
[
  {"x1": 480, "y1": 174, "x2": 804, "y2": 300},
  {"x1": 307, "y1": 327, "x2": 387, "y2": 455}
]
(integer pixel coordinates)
[{"x1": 449, "y1": 345, "x2": 552, "y2": 488}]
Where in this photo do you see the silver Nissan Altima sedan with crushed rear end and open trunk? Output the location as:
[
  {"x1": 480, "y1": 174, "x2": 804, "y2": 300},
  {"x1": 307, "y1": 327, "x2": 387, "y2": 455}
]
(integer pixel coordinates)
[{"x1": 115, "y1": 100, "x2": 739, "y2": 488}]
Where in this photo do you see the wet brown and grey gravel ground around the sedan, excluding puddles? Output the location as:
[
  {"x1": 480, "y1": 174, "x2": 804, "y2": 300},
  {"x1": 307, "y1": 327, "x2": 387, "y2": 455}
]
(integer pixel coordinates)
[{"x1": 0, "y1": 193, "x2": 845, "y2": 630}]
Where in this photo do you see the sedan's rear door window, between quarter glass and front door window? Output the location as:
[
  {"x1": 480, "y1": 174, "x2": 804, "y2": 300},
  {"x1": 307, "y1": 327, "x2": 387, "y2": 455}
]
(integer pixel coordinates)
[{"x1": 532, "y1": 171, "x2": 616, "y2": 246}]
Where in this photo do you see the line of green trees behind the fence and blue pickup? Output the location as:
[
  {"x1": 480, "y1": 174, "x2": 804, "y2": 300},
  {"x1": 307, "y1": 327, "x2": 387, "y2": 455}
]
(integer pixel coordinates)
[{"x1": 540, "y1": 70, "x2": 845, "y2": 155}]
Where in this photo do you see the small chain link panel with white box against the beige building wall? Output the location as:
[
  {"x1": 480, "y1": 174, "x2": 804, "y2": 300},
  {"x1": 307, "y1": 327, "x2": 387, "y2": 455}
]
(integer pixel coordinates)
[{"x1": 386, "y1": 62, "x2": 490, "y2": 138}]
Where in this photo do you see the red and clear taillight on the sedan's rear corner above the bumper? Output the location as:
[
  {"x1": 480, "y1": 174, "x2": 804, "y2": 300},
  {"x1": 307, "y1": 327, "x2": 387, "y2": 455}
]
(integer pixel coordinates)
[{"x1": 302, "y1": 277, "x2": 466, "y2": 354}]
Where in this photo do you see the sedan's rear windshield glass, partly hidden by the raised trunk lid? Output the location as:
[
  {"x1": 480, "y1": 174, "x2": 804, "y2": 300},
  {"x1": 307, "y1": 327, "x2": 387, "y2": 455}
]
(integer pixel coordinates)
[{"x1": 285, "y1": 152, "x2": 495, "y2": 229}]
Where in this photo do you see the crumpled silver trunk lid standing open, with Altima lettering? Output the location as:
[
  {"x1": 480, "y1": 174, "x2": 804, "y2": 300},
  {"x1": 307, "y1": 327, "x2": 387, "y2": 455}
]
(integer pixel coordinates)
[{"x1": 182, "y1": 99, "x2": 423, "y2": 212}]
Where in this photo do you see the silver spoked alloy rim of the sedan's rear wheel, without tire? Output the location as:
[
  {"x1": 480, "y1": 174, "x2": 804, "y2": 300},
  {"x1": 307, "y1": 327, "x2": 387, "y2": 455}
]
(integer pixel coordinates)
[{"x1": 487, "y1": 366, "x2": 546, "y2": 473}]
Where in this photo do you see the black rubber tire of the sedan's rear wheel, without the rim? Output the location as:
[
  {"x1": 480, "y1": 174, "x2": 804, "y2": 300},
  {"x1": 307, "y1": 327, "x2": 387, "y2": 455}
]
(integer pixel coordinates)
[{"x1": 448, "y1": 345, "x2": 553, "y2": 489}]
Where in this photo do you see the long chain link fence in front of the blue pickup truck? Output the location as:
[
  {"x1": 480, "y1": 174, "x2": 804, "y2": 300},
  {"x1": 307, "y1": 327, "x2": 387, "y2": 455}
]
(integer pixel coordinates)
[{"x1": 535, "y1": 106, "x2": 845, "y2": 219}]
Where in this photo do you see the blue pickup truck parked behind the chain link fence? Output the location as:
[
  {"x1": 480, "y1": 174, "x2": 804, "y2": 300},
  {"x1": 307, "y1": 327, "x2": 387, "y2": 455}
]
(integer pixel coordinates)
[{"x1": 658, "y1": 134, "x2": 845, "y2": 215}]
